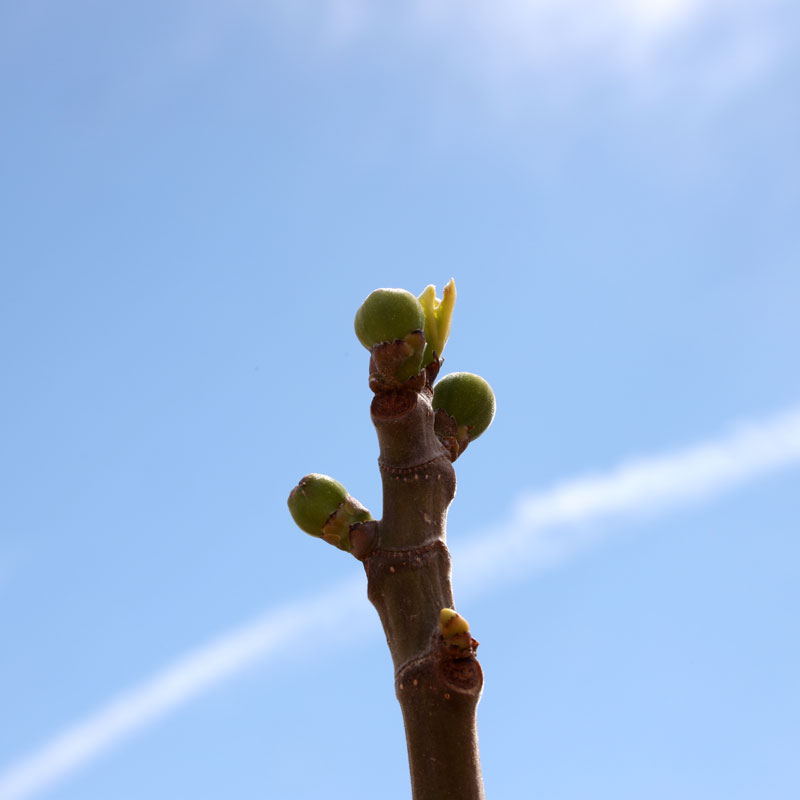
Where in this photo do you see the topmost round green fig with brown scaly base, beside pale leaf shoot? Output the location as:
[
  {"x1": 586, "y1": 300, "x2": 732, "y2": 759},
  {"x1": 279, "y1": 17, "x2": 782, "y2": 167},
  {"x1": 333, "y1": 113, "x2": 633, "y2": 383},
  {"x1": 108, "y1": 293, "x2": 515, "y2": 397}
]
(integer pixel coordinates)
[{"x1": 355, "y1": 289, "x2": 425, "y2": 387}]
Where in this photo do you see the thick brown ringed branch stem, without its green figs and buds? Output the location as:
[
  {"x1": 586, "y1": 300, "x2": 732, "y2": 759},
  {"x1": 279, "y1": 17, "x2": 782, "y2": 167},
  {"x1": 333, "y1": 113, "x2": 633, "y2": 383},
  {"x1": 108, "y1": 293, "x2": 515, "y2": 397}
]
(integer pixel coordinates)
[{"x1": 351, "y1": 384, "x2": 485, "y2": 800}]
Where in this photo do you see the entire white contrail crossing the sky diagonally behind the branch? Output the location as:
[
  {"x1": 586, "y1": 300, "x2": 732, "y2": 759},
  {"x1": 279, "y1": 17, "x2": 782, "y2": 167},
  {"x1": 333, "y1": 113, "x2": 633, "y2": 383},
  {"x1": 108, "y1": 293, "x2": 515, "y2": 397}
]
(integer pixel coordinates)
[{"x1": 0, "y1": 408, "x2": 800, "y2": 800}]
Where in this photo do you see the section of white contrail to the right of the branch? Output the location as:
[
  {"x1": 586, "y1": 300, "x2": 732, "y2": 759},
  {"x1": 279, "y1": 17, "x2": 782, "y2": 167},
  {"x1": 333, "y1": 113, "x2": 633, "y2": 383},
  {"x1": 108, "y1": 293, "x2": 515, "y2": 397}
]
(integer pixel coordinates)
[{"x1": 451, "y1": 409, "x2": 800, "y2": 594}]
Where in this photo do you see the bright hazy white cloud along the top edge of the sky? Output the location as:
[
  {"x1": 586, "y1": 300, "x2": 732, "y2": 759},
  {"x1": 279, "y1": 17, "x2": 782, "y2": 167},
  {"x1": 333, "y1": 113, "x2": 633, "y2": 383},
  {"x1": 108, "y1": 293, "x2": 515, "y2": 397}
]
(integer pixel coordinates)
[{"x1": 304, "y1": 0, "x2": 792, "y2": 92}]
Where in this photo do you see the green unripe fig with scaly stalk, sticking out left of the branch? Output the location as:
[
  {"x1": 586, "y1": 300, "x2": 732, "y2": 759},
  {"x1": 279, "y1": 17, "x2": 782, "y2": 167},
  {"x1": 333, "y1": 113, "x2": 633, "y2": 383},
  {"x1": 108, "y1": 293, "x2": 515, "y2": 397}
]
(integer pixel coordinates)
[{"x1": 288, "y1": 473, "x2": 372, "y2": 551}]
